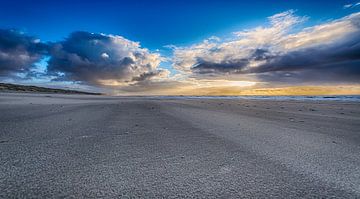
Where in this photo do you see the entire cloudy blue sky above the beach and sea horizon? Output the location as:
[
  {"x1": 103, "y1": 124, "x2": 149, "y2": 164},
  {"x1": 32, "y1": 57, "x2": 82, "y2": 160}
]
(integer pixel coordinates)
[{"x1": 0, "y1": 0, "x2": 360, "y2": 95}]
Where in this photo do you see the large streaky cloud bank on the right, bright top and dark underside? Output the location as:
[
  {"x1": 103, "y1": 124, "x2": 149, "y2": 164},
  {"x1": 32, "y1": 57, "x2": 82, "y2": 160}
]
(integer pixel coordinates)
[{"x1": 173, "y1": 10, "x2": 360, "y2": 83}]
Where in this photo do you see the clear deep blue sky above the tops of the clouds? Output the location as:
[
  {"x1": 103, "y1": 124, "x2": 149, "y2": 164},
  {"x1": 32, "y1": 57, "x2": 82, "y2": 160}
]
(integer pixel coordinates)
[{"x1": 0, "y1": 0, "x2": 354, "y2": 49}]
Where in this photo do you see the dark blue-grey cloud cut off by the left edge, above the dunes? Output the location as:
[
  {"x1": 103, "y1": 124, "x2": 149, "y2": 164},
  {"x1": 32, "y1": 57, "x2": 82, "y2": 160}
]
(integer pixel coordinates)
[{"x1": 0, "y1": 29, "x2": 47, "y2": 76}]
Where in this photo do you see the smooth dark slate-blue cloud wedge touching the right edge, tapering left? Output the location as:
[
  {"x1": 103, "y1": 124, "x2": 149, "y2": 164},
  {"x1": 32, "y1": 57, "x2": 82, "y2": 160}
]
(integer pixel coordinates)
[{"x1": 246, "y1": 35, "x2": 360, "y2": 82}]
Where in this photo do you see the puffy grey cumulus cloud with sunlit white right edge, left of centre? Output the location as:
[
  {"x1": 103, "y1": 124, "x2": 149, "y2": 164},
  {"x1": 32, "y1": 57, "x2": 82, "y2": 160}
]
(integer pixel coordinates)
[{"x1": 48, "y1": 32, "x2": 166, "y2": 86}]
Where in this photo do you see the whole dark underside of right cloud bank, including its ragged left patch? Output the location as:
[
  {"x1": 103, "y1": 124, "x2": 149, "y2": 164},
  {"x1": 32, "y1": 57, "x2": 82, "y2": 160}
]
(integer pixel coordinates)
[{"x1": 191, "y1": 32, "x2": 360, "y2": 82}]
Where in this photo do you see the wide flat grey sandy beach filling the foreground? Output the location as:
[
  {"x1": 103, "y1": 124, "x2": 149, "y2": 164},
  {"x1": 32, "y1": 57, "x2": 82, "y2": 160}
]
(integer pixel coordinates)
[{"x1": 0, "y1": 93, "x2": 360, "y2": 198}]
